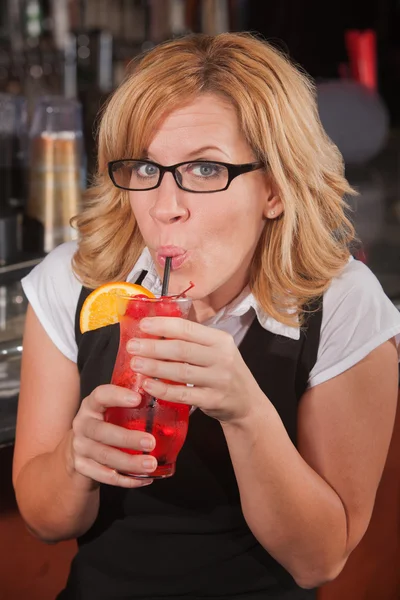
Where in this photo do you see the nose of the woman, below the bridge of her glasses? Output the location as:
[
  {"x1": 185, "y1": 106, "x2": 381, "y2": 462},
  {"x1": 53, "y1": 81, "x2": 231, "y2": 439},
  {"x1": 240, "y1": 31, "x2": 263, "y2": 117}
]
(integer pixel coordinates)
[{"x1": 150, "y1": 173, "x2": 189, "y2": 223}]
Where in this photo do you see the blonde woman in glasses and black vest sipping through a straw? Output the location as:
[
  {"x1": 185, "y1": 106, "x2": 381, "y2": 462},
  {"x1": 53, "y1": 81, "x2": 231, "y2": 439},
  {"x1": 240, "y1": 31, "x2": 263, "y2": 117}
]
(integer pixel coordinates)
[{"x1": 14, "y1": 34, "x2": 400, "y2": 600}]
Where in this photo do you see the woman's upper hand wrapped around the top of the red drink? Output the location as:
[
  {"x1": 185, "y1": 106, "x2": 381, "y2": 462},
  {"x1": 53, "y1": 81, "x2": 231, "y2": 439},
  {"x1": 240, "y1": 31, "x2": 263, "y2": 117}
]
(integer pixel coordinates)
[{"x1": 127, "y1": 317, "x2": 263, "y2": 422}]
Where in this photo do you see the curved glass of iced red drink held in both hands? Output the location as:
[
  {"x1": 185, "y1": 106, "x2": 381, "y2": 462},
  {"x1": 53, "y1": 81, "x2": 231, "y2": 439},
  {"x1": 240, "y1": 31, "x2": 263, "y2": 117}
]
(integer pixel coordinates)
[{"x1": 105, "y1": 296, "x2": 192, "y2": 479}]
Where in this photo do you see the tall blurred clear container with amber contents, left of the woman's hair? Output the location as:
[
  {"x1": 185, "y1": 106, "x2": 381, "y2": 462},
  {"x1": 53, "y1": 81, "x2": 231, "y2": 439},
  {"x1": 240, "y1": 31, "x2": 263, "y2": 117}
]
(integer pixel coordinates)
[{"x1": 26, "y1": 96, "x2": 85, "y2": 252}]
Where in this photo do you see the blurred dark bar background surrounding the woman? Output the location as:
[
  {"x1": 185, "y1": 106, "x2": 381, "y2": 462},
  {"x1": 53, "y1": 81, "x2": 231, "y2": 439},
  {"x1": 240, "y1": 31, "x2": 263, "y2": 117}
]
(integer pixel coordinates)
[{"x1": 0, "y1": 0, "x2": 400, "y2": 600}]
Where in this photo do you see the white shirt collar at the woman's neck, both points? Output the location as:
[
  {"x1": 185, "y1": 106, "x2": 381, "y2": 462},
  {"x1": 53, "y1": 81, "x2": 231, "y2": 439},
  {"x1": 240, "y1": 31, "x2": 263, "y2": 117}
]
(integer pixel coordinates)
[{"x1": 127, "y1": 248, "x2": 300, "y2": 340}]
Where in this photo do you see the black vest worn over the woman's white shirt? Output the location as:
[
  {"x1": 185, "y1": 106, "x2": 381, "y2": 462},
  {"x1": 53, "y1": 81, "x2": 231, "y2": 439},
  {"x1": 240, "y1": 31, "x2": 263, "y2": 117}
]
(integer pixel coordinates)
[{"x1": 59, "y1": 278, "x2": 322, "y2": 600}]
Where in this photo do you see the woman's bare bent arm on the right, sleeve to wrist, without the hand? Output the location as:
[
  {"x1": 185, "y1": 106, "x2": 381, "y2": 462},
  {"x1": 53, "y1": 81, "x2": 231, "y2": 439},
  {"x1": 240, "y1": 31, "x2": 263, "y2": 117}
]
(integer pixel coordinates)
[{"x1": 223, "y1": 341, "x2": 398, "y2": 587}]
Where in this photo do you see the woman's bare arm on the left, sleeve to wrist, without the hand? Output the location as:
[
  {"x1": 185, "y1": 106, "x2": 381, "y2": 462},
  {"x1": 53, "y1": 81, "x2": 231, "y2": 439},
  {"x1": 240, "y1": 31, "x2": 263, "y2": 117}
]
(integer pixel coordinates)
[{"x1": 13, "y1": 307, "x2": 99, "y2": 541}]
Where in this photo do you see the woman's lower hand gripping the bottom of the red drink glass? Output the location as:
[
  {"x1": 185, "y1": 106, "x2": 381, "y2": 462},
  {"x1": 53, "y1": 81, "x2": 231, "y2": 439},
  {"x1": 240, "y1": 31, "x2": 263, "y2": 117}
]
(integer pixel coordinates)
[{"x1": 71, "y1": 385, "x2": 157, "y2": 488}]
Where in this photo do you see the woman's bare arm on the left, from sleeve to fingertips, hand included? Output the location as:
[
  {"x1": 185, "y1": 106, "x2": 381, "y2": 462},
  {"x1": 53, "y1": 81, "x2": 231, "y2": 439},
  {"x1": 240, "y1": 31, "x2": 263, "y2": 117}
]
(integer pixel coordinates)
[{"x1": 13, "y1": 307, "x2": 156, "y2": 542}]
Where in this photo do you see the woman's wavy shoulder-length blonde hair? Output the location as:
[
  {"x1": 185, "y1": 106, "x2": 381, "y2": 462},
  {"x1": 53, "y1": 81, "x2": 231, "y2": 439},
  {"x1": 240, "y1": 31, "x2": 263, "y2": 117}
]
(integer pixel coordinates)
[{"x1": 73, "y1": 33, "x2": 354, "y2": 325}]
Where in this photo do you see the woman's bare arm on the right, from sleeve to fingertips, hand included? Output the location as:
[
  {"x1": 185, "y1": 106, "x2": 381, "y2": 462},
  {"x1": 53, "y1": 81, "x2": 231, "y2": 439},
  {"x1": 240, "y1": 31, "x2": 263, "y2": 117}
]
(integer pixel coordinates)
[{"x1": 128, "y1": 317, "x2": 398, "y2": 587}]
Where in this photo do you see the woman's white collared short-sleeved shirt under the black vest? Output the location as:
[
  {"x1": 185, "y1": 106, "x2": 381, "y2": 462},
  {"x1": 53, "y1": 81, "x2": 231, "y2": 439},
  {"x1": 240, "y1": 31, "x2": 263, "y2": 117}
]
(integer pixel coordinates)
[{"x1": 22, "y1": 242, "x2": 400, "y2": 387}]
